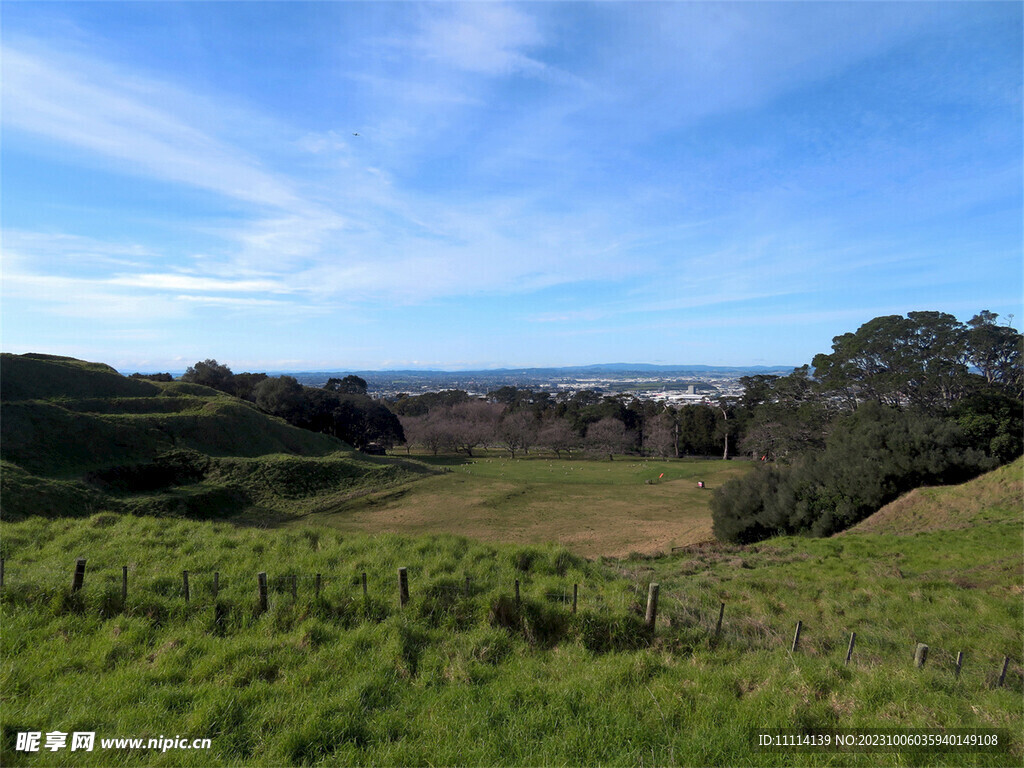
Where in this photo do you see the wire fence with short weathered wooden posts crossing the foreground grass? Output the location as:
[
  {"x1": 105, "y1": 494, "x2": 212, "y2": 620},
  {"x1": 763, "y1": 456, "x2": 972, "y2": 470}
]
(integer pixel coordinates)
[{"x1": 0, "y1": 558, "x2": 1024, "y2": 689}]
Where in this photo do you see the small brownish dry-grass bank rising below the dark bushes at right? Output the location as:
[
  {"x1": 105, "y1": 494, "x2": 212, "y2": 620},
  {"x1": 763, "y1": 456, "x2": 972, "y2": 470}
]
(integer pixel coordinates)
[{"x1": 844, "y1": 457, "x2": 1024, "y2": 536}]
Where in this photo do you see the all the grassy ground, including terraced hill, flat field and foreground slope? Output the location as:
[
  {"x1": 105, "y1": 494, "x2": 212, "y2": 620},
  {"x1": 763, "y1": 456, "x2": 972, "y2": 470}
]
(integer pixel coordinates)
[{"x1": 0, "y1": 356, "x2": 1024, "y2": 766}]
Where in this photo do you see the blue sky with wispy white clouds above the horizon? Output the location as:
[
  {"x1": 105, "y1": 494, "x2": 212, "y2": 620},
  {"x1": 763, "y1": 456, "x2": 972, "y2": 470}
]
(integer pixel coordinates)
[{"x1": 0, "y1": 2, "x2": 1024, "y2": 372}]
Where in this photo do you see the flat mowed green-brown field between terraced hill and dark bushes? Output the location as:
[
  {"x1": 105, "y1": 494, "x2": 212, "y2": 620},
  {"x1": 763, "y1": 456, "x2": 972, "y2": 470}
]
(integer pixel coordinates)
[{"x1": 287, "y1": 452, "x2": 752, "y2": 557}]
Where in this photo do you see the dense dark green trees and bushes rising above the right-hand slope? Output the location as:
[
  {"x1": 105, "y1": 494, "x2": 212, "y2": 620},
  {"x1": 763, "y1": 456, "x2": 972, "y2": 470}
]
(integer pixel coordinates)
[{"x1": 712, "y1": 311, "x2": 1024, "y2": 543}]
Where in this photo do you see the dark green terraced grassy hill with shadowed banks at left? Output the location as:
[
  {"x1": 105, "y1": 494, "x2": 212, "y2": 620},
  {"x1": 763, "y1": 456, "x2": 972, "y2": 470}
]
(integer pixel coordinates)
[{"x1": 0, "y1": 354, "x2": 429, "y2": 520}]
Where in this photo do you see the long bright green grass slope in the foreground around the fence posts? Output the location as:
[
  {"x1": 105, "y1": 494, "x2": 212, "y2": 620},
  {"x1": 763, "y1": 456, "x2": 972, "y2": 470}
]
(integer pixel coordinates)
[{"x1": 0, "y1": 460, "x2": 1024, "y2": 765}]
